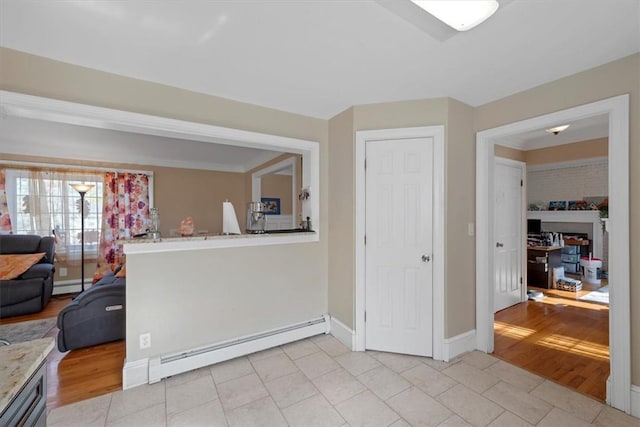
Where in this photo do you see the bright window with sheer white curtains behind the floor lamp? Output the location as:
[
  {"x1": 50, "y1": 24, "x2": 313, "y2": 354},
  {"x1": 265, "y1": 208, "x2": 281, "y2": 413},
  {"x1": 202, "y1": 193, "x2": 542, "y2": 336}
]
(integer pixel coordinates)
[{"x1": 6, "y1": 169, "x2": 103, "y2": 260}]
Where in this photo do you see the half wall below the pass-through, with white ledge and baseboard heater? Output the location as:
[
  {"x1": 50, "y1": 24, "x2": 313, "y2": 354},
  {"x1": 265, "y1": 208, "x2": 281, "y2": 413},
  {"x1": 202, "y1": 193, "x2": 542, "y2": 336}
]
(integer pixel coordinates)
[{"x1": 123, "y1": 231, "x2": 329, "y2": 389}]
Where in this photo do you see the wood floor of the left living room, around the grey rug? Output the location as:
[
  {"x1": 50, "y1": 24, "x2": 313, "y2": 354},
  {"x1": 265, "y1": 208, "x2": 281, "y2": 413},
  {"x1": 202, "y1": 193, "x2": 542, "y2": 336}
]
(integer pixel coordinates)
[{"x1": 0, "y1": 295, "x2": 125, "y2": 409}]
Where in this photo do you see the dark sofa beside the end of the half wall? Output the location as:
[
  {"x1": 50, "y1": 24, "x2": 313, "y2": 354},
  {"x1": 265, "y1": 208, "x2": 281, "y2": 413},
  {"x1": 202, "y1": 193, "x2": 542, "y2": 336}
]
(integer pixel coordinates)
[{"x1": 57, "y1": 268, "x2": 126, "y2": 352}]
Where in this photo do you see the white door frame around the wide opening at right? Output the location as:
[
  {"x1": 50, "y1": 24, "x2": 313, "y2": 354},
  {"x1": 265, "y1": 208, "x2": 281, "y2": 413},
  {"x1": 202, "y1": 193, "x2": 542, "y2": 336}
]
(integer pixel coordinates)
[{"x1": 476, "y1": 94, "x2": 631, "y2": 413}]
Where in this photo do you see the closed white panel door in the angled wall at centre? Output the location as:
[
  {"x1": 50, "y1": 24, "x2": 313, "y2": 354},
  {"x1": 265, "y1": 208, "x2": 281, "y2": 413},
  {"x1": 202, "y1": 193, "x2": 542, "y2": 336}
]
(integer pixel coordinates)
[{"x1": 365, "y1": 138, "x2": 434, "y2": 356}]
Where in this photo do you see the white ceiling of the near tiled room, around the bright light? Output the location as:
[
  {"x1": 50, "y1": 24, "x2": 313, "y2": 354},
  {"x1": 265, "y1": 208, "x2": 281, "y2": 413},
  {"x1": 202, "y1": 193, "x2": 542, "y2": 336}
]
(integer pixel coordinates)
[{"x1": 0, "y1": 0, "x2": 640, "y2": 119}]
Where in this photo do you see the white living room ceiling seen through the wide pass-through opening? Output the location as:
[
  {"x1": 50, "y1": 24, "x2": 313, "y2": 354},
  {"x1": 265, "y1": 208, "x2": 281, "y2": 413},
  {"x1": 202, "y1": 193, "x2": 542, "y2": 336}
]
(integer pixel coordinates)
[{"x1": 0, "y1": 117, "x2": 282, "y2": 173}]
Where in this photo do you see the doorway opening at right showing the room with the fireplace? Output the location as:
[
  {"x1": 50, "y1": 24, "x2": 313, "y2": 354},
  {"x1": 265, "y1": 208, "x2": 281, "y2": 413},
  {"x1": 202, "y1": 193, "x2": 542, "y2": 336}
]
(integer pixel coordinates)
[{"x1": 493, "y1": 138, "x2": 610, "y2": 401}]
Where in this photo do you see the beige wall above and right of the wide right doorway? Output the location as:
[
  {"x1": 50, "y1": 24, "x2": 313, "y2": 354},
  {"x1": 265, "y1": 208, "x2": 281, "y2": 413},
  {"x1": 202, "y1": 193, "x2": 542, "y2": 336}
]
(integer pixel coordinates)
[{"x1": 476, "y1": 54, "x2": 640, "y2": 384}]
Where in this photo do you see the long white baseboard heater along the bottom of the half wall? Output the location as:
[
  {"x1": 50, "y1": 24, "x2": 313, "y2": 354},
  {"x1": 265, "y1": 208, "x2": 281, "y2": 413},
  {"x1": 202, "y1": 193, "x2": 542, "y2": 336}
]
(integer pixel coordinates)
[{"x1": 149, "y1": 315, "x2": 331, "y2": 384}]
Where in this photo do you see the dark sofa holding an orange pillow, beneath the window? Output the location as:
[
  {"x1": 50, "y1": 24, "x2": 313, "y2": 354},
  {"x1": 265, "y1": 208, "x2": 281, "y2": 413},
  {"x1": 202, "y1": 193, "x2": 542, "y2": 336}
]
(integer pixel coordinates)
[{"x1": 0, "y1": 234, "x2": 55, "y2": 318}]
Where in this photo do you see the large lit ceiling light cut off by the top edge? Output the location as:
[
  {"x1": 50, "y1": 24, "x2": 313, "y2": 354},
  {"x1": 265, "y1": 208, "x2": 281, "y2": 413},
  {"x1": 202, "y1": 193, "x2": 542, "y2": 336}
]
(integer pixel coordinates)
[{"x1": 411, "y1": 0, "x2": 498, "y2": 31}]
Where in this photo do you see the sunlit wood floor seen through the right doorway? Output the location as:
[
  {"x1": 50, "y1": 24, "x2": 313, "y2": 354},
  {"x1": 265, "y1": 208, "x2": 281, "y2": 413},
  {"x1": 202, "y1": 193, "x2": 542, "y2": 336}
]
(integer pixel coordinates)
[{"x1": 493, "y1": 283, "x2": 610, "y2": 402}]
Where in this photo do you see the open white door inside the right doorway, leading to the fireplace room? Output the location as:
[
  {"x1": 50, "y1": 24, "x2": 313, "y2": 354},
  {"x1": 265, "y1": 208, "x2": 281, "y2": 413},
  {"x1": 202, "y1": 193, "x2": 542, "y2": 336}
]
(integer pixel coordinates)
[{"x1": 493, "y1": 158, "x2": 524, "y2": 312}]
